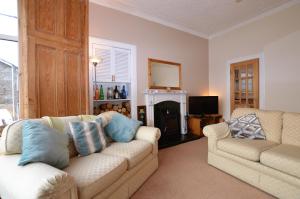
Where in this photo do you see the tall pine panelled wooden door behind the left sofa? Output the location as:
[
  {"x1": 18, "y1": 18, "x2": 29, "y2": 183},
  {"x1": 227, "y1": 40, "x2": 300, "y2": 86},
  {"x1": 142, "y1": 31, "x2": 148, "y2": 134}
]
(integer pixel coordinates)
[{"x1": 19, "y1": 0, "x2": 89, "y2": 118}]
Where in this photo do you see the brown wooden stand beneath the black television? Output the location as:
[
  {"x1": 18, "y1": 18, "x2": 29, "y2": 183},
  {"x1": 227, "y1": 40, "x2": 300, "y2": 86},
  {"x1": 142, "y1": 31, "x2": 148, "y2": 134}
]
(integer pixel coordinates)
[{"x1": 188, "y1": 114, "x2": 223, "y2": 137}]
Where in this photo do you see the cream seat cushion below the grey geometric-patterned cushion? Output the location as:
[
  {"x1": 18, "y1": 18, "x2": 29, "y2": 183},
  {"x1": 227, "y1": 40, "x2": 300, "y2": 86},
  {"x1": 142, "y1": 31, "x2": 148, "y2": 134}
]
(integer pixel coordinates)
[{"x1": 217, "y1": 138, "x2": 277, "y2": 162}]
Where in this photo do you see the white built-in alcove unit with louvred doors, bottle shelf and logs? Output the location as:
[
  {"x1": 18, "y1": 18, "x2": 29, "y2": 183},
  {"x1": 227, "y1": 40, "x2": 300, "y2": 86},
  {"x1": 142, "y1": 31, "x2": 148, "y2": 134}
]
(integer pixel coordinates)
[{"x1": 89, "y1": 37, "x2": 137, "y2": 118}]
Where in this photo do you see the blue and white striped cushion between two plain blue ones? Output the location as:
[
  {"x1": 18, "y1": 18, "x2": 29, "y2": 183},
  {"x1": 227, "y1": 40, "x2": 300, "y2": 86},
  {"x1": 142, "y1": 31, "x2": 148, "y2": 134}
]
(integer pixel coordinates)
[{"x1": 69, "y1": 118, "x2": 107, "y2": 156}]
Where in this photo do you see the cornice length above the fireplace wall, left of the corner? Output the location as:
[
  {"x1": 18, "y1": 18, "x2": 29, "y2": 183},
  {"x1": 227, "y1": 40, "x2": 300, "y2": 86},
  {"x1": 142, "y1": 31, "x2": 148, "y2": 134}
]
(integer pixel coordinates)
[{"x1": 90, "y1": 0, "x2": 209, "y2": 39}]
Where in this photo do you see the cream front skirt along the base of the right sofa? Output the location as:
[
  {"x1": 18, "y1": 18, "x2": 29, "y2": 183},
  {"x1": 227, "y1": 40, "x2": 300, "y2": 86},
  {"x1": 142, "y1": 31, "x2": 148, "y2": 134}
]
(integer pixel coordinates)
[{"x1": 208, "y1": 152, "x2": 300, "y2": 199}]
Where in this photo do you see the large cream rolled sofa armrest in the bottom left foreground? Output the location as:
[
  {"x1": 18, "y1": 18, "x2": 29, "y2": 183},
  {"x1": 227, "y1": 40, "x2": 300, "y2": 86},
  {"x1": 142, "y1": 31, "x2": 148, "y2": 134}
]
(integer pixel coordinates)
[{"x1": 0, "y1": 155, "x2": 78, "y2": 199}]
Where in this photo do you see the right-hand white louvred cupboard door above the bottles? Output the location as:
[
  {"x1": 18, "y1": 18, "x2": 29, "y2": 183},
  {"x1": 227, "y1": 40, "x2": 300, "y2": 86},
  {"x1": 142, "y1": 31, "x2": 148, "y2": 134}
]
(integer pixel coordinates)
[{"x1": 114, "y1": 48, "x2": 131, "y2": 82}]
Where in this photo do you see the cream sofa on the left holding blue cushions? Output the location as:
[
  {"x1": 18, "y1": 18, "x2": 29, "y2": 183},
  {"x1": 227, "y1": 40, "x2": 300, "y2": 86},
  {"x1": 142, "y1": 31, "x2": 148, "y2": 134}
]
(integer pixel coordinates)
[{"x1": 0, "y1": 114, "x2": 160, "y2": 199}]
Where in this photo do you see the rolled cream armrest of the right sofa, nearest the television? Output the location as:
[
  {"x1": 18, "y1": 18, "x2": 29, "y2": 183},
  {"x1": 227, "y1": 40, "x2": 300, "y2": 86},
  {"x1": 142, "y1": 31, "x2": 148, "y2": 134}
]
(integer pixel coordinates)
[{"x1": 203, "y1": 122, "x2": 230, "y2": 152}]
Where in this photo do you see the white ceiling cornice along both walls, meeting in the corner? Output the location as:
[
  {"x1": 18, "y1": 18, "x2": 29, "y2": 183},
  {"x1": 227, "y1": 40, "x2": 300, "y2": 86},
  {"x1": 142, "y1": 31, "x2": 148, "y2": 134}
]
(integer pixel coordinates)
[{"x1": 90, "y1": 0, "x2": 300, "y2": 39}]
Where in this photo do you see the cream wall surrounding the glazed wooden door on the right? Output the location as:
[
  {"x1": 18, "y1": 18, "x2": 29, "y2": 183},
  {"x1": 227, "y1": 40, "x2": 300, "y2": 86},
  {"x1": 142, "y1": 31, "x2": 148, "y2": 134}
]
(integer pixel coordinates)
[{"x1": 209, "y1": 4, "x2": 300, "y2": 119}]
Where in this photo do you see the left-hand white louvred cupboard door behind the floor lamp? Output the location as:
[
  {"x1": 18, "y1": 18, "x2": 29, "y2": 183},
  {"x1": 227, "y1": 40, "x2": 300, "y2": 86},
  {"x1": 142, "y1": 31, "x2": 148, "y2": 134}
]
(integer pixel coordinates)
[{"x1": 93, "y1": 44, "x2": 113, "y2": 82}]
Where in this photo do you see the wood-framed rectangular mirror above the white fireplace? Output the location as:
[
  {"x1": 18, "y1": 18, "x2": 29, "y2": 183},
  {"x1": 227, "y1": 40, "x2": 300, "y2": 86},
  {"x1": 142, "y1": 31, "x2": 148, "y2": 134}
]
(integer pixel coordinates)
[{"x1": 148, "y1": 58, "x2": 181, "y2": 90}]
